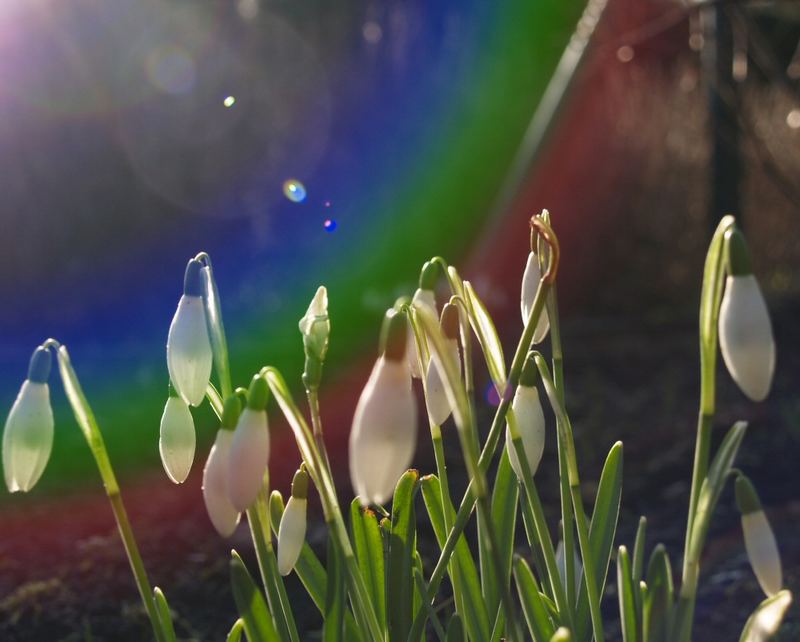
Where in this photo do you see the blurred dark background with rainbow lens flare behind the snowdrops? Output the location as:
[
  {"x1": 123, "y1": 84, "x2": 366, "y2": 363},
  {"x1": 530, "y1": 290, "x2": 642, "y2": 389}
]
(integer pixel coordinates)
[{"x1": 0, "y1": 0, "x2": 800, "y2": 640}]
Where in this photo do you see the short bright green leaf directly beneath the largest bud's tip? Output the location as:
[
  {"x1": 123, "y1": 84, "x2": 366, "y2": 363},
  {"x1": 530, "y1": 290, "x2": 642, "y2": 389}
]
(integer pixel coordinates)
[{"x1": 350, "y1": 498, "x2": 386, "y2": 627}]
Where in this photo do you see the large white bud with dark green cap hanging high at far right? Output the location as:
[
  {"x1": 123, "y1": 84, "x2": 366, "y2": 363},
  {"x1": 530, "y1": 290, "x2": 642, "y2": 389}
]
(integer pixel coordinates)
[{"x1": 719, "y1": 230, "x2": 775, "y2": 401}]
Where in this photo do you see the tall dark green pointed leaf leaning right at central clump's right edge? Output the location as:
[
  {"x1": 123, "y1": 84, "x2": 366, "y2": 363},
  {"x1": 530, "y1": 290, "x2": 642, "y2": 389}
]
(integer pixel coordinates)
[{"x1": 575, "y1": 441, "x2": 623, "y2": 640}]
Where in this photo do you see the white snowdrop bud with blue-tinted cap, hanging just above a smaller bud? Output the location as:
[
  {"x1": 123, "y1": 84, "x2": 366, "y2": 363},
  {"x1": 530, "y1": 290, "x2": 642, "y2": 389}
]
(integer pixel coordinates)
[{"x1": 167, "y1": 259, "x2": 213, "y2": 406}]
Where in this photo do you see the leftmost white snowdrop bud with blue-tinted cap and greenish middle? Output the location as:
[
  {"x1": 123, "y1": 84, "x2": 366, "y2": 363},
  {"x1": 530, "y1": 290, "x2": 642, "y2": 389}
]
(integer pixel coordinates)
[{"x1": 3, "y1": 346, "x2": 53, "y2": 493}]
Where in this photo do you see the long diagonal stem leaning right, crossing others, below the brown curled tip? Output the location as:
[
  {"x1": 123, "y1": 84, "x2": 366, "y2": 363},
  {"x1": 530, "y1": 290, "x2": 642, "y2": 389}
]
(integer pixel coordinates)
[{"x1": 408, "y1": 272, "x2": 551, "y2": 642}]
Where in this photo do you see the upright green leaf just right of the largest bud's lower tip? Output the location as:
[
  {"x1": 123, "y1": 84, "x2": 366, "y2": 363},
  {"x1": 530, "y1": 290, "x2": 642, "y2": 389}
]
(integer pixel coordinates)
[{"x1": 386, "y1": 470, "x2": 419, "y2": 642}]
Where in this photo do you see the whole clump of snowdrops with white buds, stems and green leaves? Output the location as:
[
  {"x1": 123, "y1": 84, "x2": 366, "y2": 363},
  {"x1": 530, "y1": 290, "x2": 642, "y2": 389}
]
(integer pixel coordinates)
[{"x1": 3, "y1": 211, "x2": 791, "y2": 642}]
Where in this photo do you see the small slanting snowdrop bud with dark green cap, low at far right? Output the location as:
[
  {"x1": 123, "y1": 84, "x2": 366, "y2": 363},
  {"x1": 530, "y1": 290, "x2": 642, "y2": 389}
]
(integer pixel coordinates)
[{"x1": 736, "y1": 475, "x2": 783, "y2": 597}]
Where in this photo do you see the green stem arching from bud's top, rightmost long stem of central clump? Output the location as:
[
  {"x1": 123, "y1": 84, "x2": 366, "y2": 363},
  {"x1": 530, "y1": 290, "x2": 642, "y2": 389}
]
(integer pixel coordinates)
[{"x1": 535, "y1": 353, "x2": 605, "y2": 642}]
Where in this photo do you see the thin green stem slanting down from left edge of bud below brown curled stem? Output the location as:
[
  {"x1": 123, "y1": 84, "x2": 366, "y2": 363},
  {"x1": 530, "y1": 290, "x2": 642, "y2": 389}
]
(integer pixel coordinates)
[{"x1": 507, "y1": 410, "x2": 575, "y2": 630}]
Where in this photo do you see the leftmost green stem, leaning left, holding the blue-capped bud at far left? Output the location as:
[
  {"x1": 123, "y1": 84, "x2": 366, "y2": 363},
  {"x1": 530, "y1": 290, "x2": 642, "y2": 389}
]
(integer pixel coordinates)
[{"x1": 53, "y1": 339, "x2": 167, "y2": 642}]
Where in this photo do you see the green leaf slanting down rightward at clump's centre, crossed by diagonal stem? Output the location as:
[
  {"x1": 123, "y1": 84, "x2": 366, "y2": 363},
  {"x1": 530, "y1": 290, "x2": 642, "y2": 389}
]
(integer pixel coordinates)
[{"x1": 420, "y1": 475, "x2": 490, "y2": 642}]
